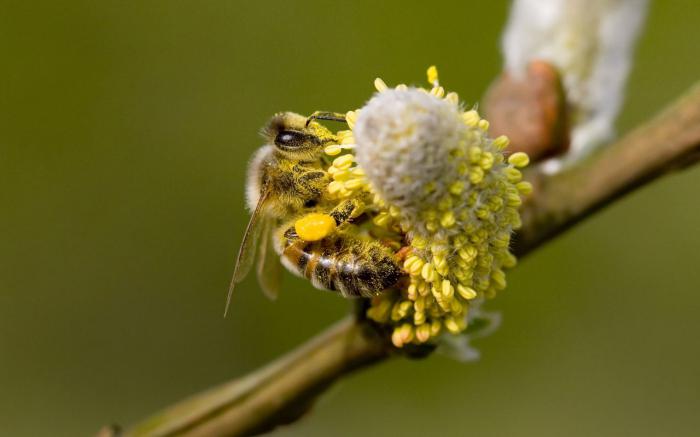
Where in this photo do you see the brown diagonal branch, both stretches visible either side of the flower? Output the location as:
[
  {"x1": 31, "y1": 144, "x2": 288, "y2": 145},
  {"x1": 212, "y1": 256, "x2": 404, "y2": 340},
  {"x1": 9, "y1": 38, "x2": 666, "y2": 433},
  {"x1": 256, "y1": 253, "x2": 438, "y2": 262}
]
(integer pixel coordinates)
[{"x1": 120, "y1": 85, "x2": 700, "y2": 436}]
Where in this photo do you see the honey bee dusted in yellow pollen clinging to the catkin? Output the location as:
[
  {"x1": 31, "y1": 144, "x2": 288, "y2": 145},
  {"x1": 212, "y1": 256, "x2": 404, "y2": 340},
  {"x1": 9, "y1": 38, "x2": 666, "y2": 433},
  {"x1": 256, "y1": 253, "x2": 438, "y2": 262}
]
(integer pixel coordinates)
[{"x1": 226, "y1": 112, "x2": 402, "y2": 310}]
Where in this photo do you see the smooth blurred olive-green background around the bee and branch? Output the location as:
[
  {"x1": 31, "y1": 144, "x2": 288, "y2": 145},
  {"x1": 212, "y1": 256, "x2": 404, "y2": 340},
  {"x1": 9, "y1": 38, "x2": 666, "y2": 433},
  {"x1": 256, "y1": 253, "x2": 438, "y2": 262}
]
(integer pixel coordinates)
[{"x1": 0, "y1": 0, "x2": 700, "y2": 436}]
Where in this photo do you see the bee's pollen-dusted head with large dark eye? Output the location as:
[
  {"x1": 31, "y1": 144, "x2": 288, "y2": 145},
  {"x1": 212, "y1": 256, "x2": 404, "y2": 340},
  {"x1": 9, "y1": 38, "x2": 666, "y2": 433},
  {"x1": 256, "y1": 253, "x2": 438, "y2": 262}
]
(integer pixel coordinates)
[{"x1": 262, "y1": 112, "x2": 338, "y2": 160}]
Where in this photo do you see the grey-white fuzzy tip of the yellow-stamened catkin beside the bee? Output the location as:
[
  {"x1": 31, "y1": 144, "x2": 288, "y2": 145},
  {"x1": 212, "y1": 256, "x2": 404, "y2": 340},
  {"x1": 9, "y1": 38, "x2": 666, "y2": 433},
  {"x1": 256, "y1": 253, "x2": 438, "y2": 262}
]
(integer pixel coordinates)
[{"x1": 354, "y1": 88, "x2": 467, "y2": 214}]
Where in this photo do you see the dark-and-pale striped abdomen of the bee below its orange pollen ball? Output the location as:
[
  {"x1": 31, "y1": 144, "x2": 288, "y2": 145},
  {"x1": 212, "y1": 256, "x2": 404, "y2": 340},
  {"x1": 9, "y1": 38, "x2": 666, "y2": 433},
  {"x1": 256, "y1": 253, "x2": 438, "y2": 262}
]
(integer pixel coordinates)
[{"x1": 282, "y1": 235, "x2": 401, "y2": 297}]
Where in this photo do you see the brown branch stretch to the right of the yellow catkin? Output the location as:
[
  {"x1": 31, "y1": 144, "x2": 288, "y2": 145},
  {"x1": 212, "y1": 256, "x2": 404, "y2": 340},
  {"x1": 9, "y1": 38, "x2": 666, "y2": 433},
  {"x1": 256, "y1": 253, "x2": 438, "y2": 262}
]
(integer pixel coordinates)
[{"x1": 514, "y1": 83, "x2": 700, "y2": 256}]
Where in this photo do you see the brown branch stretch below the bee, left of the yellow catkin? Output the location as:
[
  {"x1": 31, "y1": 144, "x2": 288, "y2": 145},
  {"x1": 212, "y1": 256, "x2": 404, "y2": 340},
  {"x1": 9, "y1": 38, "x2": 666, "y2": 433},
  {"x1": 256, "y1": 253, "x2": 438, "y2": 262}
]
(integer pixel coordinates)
[{"x1": 126, "y1": 317, "x2": 390, "y2": 436}]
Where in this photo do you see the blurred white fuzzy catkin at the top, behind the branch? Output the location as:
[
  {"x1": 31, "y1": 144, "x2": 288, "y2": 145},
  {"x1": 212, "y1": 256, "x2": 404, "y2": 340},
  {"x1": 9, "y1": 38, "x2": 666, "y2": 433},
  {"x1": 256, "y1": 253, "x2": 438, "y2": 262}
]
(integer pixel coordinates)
[{"x1": 503, "y1": 0, "x2": 648, "y2": 165}]
